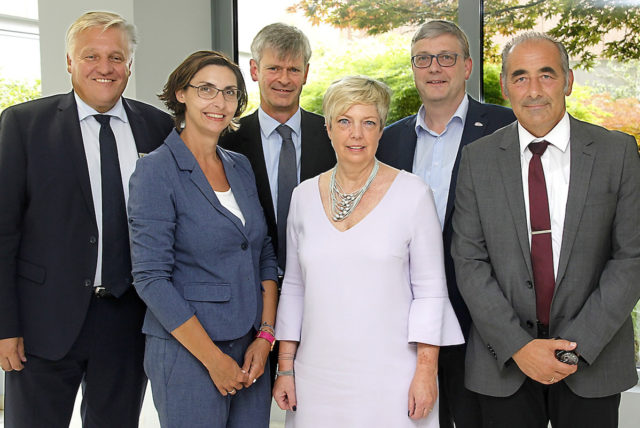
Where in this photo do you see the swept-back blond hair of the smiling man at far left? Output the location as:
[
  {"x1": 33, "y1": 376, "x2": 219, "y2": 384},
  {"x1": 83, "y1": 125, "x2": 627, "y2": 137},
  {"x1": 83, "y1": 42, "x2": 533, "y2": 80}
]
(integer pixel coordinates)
[{"x1": 66, "y1": 11, "x2": 138, "y2": 62}]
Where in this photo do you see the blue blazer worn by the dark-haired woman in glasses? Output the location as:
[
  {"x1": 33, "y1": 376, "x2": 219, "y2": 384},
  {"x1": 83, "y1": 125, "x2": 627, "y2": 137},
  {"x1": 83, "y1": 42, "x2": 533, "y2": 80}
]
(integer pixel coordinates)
[{"x1": 128, "y1": 130, "x2": 277, "y2": 341}]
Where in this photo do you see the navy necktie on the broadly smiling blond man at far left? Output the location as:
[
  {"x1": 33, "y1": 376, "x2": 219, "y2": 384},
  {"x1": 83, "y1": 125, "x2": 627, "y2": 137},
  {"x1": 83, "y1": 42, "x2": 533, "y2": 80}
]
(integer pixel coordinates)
[{"x1": 93, "y1": 114, "x2": 131, "y2": 297}]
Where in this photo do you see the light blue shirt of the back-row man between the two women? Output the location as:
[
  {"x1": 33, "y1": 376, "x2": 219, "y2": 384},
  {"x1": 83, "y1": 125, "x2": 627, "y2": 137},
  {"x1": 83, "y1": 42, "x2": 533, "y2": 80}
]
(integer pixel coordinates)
[{"x1": 258, "y1": 107, "x2": 302, "y2": 213}]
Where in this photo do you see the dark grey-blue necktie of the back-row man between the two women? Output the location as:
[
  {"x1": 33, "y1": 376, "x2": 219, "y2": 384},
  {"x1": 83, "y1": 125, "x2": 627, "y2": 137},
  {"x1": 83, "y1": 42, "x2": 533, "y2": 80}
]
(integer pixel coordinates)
[{"x1": 276, "y1": 125, "x2": 298, "y2": 271}]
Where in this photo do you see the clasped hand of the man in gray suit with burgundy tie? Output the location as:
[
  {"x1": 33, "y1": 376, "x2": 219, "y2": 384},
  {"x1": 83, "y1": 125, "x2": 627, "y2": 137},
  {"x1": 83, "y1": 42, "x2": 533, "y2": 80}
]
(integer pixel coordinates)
[{"x1": 513, "y1": 339, "x2": 578, "y2": 385}]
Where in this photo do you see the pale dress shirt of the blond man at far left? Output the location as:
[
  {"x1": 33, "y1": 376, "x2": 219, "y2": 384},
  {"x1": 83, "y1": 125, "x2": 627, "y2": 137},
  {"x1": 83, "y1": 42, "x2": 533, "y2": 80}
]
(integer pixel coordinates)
[{"x1": 73, "y1": 92, "x2": 138, "y2": 287}]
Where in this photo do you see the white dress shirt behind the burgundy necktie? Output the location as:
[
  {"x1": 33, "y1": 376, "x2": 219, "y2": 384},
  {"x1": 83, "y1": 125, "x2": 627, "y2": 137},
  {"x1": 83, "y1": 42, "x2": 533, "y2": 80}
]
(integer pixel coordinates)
[{"x1": 518, "y1": 112, "x2": 571, "y2": 275}]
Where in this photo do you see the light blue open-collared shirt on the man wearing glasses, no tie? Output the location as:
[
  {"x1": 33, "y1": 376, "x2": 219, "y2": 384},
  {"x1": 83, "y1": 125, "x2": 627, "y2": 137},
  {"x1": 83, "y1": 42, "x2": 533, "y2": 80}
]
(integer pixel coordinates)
[{"x1": 413, "y1": 95, "x2": 469, "y2": 229}]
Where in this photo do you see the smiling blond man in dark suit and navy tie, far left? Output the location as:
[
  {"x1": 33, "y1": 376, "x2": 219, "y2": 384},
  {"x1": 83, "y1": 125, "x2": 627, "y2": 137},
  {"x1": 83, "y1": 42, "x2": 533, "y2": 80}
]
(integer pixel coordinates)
[{"x1": 0, "y1": 12, "x2": 172, "y2": 428}]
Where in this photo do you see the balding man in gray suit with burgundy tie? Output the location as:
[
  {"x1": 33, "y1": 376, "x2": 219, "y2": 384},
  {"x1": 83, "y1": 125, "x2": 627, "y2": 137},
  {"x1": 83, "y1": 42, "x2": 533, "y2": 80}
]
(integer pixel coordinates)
[{"x1": 452, "y1": 33, "x2": 640, "y2": 428}]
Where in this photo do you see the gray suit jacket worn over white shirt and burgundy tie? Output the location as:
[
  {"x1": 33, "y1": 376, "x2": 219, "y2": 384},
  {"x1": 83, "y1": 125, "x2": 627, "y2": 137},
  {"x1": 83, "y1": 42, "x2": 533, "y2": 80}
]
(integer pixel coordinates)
[{"x1": 452, "y1": 118, "x2": 640, "y2": 397}]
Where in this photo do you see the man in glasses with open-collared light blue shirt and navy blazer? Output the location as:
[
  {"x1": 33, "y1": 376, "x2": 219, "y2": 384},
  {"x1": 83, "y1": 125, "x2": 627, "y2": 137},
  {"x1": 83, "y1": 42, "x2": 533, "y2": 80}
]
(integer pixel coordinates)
[{"x1": 377, "y1": 20, "x2": 515, "y2": 428}]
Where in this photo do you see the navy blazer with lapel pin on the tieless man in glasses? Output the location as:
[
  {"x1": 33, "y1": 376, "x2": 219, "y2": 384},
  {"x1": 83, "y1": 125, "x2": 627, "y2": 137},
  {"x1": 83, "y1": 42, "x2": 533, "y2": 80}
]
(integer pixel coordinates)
[{"x1": 376, "y1": 95, "x2": 516, "y2": 339}]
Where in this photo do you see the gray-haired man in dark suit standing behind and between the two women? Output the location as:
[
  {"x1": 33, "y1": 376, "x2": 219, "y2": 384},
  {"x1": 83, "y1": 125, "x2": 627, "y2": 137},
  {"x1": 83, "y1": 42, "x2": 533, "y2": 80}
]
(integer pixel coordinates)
[{"x1": 220, "y1": 23, "x2": 336, "y2": 388}]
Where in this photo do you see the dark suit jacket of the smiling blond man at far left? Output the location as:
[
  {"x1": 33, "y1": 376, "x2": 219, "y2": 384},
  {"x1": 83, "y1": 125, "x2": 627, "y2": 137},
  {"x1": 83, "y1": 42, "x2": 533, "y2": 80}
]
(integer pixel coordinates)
[{"x1": 0, "y1": 92, "x2": 172, "y2": 360}]
